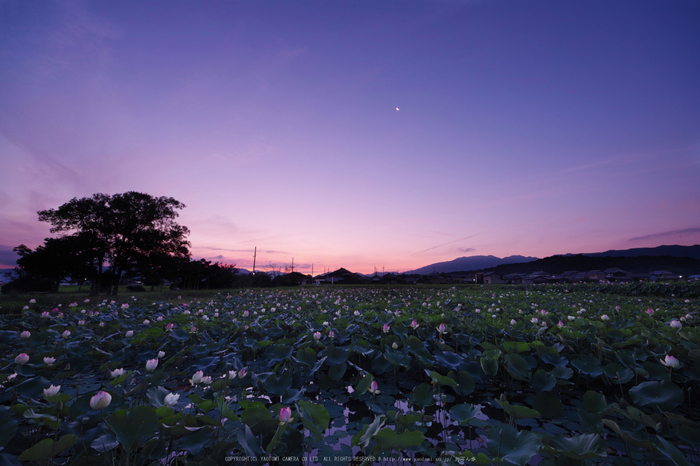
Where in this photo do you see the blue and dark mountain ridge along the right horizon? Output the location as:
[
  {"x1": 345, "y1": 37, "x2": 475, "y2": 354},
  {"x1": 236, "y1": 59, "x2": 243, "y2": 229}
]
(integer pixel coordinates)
[{"x1": 405, "y1": 245, "x2": 700, "y2": 275}]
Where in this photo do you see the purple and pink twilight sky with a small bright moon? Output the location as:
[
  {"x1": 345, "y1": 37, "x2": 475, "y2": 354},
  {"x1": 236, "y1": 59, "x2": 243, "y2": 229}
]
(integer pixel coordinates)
[{"x1": 0, "y1": 0, "x2": 700, "y2": 273}]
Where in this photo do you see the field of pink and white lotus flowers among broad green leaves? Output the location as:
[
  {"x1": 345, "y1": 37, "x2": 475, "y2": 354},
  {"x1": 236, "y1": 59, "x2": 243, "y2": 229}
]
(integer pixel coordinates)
[{"x1": 0, "y1": 285, "x2": 700, "y2": 465}]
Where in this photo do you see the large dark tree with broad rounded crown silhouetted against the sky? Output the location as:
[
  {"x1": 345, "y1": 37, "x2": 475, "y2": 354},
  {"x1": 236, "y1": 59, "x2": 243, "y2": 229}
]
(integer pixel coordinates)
[{"x1": 32, "y1": 191, "x2": 190, "y2": 294}]
